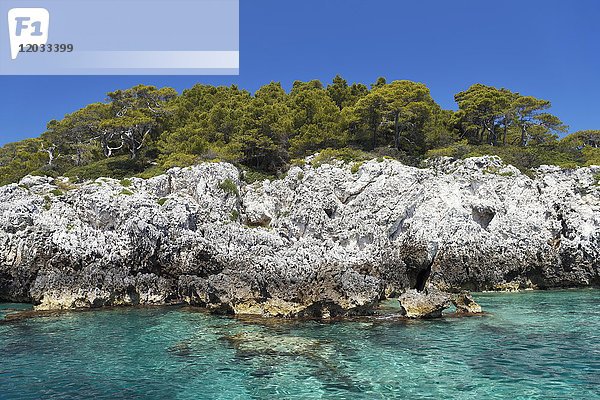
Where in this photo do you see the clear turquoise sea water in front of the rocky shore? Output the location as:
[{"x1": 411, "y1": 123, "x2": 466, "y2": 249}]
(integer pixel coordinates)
[{"x1": 0, "y1": 290, "x2": 600, "y2": 400}]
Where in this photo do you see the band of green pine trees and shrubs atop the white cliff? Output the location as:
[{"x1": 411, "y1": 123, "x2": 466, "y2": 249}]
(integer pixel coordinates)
[{"x1": 0, "y1": 76, "x2": 600, "y2": 184}]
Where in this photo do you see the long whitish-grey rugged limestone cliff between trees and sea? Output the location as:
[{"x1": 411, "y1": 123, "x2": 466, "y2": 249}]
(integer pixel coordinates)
[{"x1": 0, "y1": 157, "x2": 600, "y2": 317}]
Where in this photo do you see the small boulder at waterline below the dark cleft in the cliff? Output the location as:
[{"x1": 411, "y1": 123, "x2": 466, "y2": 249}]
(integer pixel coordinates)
[{"x1": 398, "y1": 289, "x2": 452, "y2": 318}]
